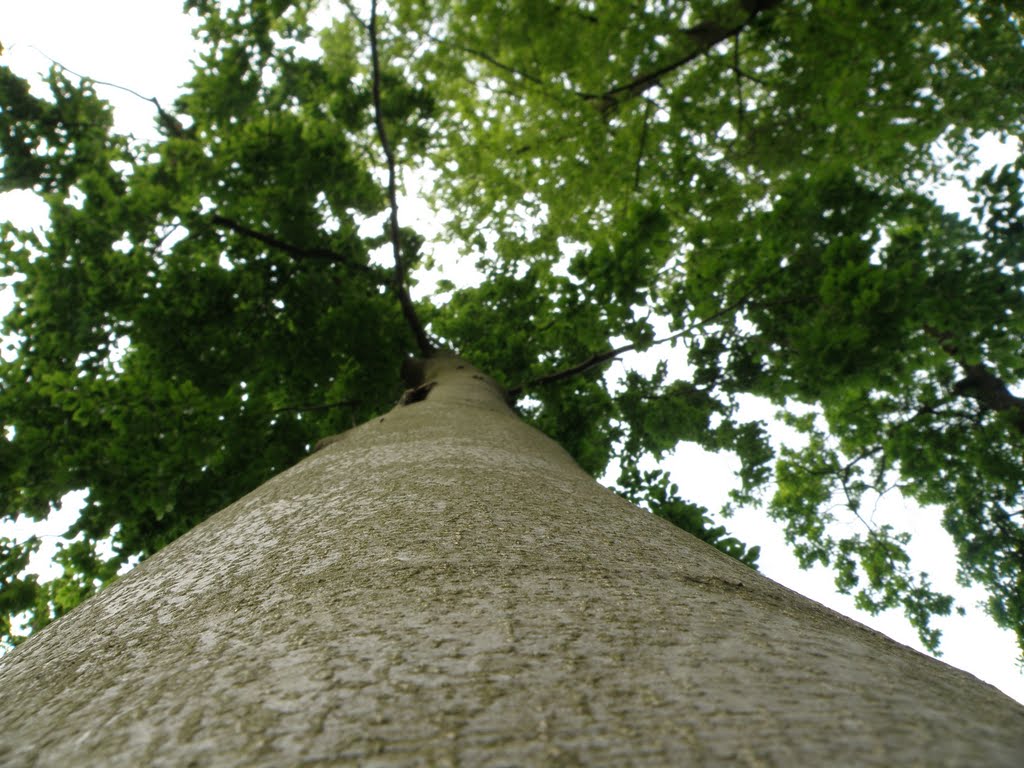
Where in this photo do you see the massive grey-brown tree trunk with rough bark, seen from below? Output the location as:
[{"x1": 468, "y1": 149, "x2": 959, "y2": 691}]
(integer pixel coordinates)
[{"x1": 0, "y1": 358, "x2": 1024, "y2": 768}]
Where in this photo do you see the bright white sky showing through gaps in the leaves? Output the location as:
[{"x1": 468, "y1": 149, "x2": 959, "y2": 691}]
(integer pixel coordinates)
[{"x1": 0, "y1": 0, "x2": 1024, "y2": 702}]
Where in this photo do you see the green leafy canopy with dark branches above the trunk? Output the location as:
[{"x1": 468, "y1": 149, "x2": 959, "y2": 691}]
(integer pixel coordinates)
[{"x1": 0, "y1": 0, "x2": 1024, "y2": 663}]
